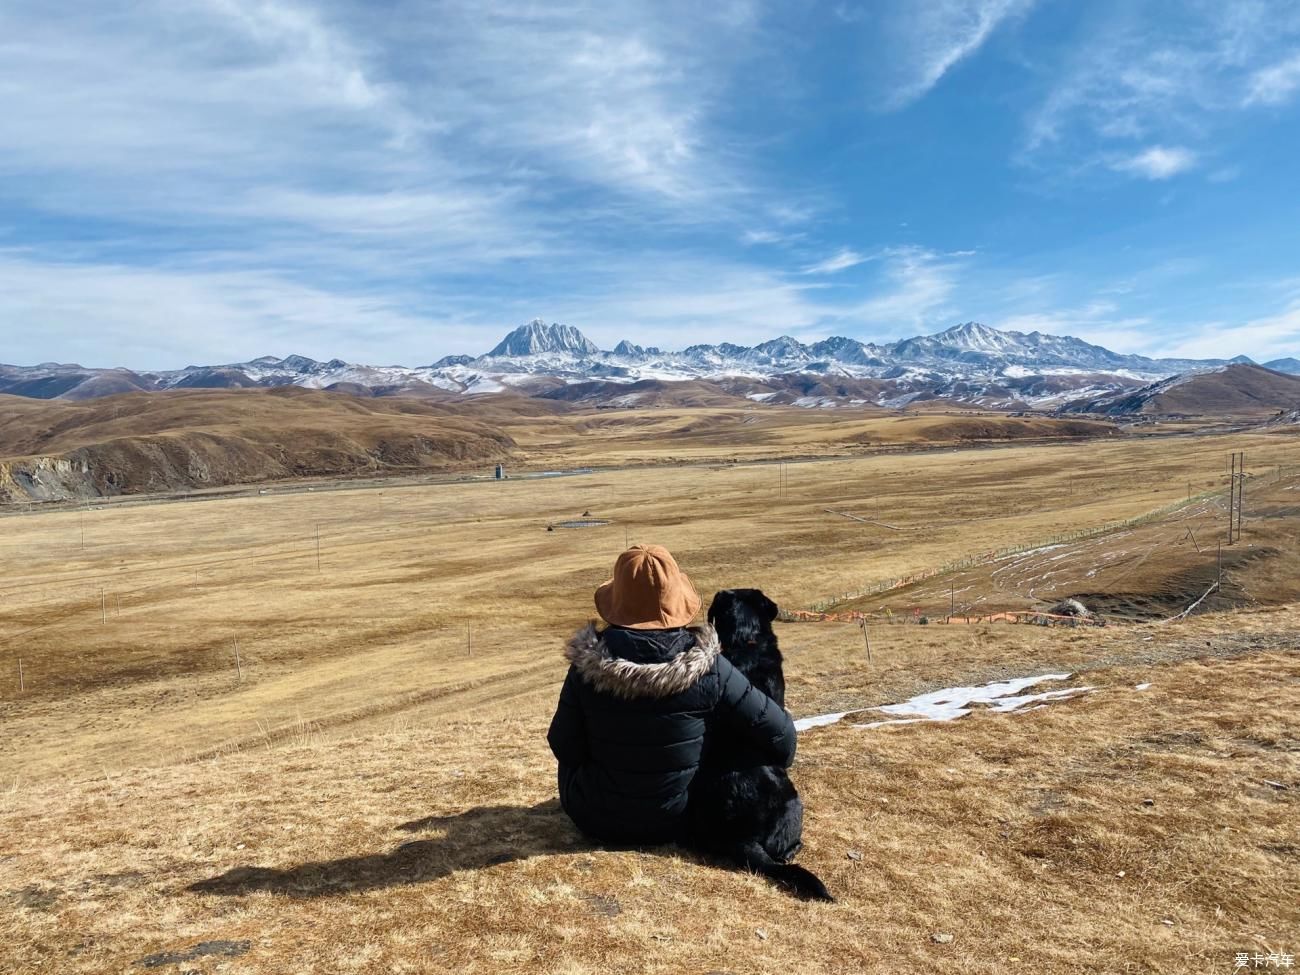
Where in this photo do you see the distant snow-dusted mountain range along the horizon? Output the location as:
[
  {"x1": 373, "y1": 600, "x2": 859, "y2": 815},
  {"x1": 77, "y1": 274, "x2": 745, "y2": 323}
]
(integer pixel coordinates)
[{"x1": 0, "y1": 319, "x2": 1300, "y2": 410}]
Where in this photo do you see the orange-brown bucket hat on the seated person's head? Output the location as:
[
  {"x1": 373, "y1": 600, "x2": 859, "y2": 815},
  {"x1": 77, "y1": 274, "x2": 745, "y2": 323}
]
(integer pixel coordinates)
[{"x1": 595, "y1": 545, "x2": 699, "y2": 629}]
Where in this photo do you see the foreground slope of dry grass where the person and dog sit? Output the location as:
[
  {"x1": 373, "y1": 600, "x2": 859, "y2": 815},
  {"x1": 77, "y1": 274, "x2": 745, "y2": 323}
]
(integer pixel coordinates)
[{"x1": 0, "y1": 610, "x2": 1300, "y2": 975}]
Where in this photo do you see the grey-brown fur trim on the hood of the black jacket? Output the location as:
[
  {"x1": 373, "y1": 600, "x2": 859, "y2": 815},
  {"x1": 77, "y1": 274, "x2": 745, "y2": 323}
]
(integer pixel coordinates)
[{"x1": 564, "y1": 623, "x2": 722, "y2": 699}]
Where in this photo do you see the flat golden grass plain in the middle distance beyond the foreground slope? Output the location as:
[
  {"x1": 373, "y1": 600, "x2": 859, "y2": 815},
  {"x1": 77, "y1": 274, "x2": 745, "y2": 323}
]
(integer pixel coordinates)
[{"x1": 0, "y1": 432, "x2": 1294, "y2": 781}]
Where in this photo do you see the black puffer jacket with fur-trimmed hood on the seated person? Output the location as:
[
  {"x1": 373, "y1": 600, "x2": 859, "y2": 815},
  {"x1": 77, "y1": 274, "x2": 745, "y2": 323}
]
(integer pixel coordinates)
[{"x1": 546, "y1": 627, "x2": 794, "y2": 845}]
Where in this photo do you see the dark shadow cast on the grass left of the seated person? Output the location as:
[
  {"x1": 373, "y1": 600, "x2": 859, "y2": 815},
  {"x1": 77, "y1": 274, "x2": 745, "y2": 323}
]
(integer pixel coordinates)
[{"x1": 187, "y1": 800, "x2": 595, "y2": 897}]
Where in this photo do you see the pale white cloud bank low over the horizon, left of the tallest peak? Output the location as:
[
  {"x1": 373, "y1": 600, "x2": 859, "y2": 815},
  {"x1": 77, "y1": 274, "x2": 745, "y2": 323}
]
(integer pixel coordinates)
[{"x1": 0, "y1": 254, "x2": 465, "y2": 369}]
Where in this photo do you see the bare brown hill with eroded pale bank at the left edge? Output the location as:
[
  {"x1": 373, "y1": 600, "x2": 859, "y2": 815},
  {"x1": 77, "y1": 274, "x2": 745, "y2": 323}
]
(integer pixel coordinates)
[{"x1": 0, "y1": 386, "x2": 515, "y2": 501}]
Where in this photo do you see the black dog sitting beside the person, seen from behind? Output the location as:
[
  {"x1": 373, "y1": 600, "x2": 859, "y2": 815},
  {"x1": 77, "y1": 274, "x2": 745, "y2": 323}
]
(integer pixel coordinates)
[{"x1": 688, "y1": 589, "x2": 835, "y2": 901}]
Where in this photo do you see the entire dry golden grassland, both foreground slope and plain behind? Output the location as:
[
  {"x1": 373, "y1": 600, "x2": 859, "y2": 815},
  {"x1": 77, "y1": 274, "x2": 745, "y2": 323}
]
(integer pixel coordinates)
[{"x1": 0, "y1": 411, "x2": 1300, "y2": 975}]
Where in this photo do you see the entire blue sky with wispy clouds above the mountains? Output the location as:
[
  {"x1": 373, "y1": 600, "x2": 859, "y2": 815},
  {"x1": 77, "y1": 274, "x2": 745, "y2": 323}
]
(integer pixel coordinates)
[{"x1": 0, "y1": 0, "x2": 1300, "y2": 368}]
